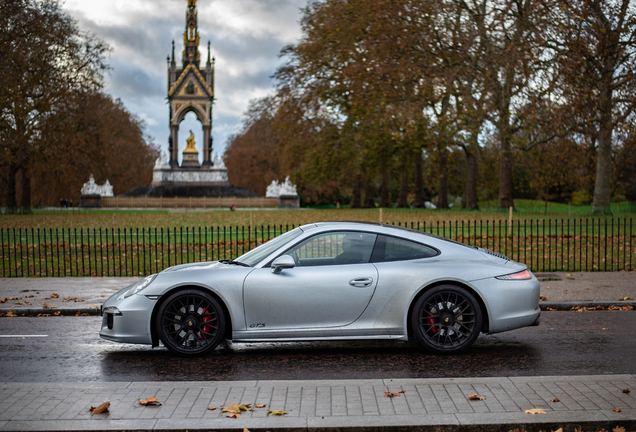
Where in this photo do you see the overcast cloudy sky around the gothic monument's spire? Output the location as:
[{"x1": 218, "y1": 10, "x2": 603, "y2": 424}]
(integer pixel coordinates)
[{"x1": 64, "y1": 0, "x2": 307, "y2": 161}]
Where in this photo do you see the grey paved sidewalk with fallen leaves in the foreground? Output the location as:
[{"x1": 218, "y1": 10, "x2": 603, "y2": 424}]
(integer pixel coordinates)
[{"x1": 0, "y1": 375, "x2": 636, "y2": 432}]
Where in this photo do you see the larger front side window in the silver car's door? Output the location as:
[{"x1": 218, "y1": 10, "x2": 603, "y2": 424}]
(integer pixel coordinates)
[{"x1": 285, "y1": 231, "x2": 377, "y2": 267}]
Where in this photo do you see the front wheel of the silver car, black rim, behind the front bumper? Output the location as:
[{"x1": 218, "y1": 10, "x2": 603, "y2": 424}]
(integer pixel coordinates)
[{"x1": 156, "y1": 289, "x2": 225, "y2": 355}]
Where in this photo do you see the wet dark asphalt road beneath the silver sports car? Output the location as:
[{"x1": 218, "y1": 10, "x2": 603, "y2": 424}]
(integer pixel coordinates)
[{"x1": 0, "y1": 312, "x2": 636, "y2": 382}]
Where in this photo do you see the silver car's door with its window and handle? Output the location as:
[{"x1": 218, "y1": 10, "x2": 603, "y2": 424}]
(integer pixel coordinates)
[{"x1": 243, "y1": 232, "x2": 378, "y2": 330}]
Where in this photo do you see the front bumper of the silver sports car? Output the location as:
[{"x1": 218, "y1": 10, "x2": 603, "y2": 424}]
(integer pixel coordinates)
[{"x1": 99, "y1": 290, "x2": 157, "y2": 344}]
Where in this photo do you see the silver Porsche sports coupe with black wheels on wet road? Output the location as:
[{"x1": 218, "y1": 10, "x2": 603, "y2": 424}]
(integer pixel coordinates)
[{"x1": 100, "y1": 222, "x2": 541, "y2": 355}]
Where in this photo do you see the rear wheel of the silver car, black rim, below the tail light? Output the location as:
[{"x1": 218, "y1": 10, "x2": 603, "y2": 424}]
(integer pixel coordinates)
[{"x1": 411, "y1": 285, "x2": 482, "y2": 354}]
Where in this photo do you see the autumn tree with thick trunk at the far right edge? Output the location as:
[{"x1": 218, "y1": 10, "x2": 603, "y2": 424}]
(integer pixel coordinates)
[{"x1": 550, "y1": 0, "x2": 636, "y2": 213}]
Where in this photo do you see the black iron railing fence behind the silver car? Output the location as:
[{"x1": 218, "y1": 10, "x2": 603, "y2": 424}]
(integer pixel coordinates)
[{"x1": 0, "y1": 218, "x2": 636, "y2": 277}]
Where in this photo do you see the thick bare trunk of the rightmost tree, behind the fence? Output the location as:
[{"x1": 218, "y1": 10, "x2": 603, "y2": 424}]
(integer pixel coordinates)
[{"x1": 592, "y1": 78, "x2": 612, "y2": 213}]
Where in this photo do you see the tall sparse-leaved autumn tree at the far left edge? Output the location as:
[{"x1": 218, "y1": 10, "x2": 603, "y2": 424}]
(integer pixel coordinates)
[{"x1": 0, "y1": 0, "x2": 107, "y2": 207}]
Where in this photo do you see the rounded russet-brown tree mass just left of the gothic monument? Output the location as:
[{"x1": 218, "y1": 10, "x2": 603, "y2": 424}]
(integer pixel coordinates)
[{"x1": 30, "y1": 92, "x2": 159, "y2": 205}]
